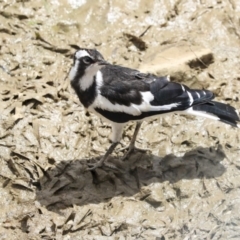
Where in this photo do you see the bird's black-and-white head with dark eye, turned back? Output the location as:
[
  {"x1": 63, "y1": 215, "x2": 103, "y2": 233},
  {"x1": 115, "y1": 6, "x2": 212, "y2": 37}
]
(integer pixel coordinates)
[{"x1": 69, "y1": 48, "x2": 109, "y2": 81}]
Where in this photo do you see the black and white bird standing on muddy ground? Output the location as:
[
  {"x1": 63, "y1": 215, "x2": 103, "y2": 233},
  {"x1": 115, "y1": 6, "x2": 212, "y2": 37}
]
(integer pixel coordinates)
[{"x1": 69, "y1": 48, "x2": 240, "y2": 170}]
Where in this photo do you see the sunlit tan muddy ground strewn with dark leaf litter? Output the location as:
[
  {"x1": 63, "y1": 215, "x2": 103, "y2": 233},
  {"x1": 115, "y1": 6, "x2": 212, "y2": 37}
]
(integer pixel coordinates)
[{"x1": 0, "y1": 0, "x2": 240, "y2": 240}]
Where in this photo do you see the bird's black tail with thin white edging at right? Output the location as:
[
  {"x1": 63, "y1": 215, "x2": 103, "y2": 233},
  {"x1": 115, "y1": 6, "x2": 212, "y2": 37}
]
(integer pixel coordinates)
[{"x1": 192, "y1": 101, "x2": 240, "y2": 127}]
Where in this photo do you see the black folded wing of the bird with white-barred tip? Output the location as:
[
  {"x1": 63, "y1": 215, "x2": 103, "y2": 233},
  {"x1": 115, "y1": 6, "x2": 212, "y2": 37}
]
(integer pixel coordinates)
[{"x1": 100, "y1": 65, "x2": 214, "y2": 111}]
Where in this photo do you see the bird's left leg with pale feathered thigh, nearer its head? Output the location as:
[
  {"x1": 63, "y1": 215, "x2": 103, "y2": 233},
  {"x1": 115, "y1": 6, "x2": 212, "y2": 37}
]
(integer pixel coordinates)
[{"x1": 87, "y1": 122, "x2": 125, "y2": 171}]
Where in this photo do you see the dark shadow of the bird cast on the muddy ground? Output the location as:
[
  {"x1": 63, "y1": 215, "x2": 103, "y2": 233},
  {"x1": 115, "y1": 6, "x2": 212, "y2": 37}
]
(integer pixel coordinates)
[{"x1": 36, "y1": 145, "x2": 225, "y2": 211}]
